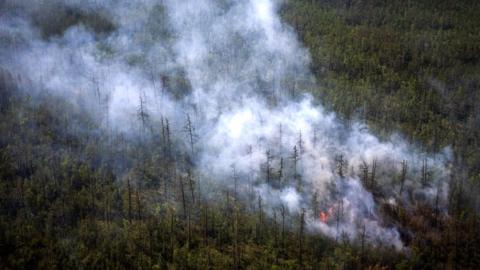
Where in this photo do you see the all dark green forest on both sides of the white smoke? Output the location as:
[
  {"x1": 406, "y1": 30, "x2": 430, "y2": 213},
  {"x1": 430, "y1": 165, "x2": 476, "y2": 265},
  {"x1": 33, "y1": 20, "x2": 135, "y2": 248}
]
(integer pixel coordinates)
[{"x1": 0, "y1": 0, "x2": 480, "y2": 269}]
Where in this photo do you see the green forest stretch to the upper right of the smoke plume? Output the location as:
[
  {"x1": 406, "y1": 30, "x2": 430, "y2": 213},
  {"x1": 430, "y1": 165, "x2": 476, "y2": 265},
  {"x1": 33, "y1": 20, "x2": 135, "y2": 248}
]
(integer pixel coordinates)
[{"x1": 282, "y1": 0, "x2": 480, "y2": 184}]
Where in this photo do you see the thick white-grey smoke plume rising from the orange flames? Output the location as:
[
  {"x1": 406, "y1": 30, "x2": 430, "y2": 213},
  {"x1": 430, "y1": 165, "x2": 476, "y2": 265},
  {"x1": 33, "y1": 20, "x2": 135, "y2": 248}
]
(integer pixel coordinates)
[{"x1": 0, "y1": 0, "x2": 448, "y2": 248}]
